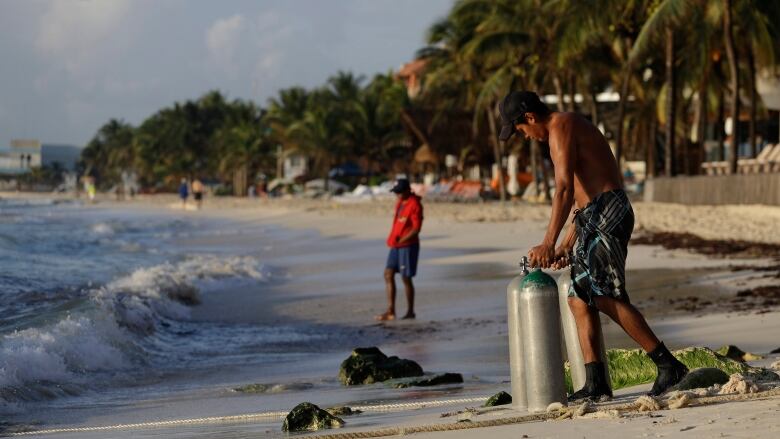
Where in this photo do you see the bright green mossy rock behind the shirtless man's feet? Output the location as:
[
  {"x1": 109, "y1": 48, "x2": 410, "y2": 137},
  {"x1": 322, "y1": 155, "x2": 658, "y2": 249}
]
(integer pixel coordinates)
[{"x1": 588, "y1": 347, "x2": 778, "y2": 390}]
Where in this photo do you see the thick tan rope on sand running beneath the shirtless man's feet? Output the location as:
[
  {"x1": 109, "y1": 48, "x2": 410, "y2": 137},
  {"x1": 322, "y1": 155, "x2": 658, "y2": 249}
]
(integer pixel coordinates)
[{"x1": 317, "y1": 387, "x2": 780, "y2": 439}]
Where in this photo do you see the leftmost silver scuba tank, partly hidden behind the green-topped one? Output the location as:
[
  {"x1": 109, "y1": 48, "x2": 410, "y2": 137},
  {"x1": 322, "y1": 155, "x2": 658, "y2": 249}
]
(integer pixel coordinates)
[{"x1": 506, "y1": 264, "x2": 528, "y2": 410}]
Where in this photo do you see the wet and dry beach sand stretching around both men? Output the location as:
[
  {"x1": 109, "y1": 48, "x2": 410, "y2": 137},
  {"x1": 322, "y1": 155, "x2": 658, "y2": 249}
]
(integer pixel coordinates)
[{"x1": 2, "y1": 194, "x2": 780, "y2": 438}]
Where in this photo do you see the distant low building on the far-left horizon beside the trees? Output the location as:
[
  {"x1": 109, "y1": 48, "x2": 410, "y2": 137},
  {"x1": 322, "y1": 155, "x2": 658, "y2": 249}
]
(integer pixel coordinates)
[{"x1": 0, "y1": 139, "x2": 81, "y2": 175}]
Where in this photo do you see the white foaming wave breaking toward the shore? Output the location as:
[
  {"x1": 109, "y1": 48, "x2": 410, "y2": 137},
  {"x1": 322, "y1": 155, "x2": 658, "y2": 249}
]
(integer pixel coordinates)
[{"x1": 0, "y1": 256, "x2": 270, "y2": 401}]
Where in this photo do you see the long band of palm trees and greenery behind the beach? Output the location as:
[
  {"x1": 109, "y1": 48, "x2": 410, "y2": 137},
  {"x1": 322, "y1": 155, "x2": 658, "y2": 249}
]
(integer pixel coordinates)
[{"x1": 82, "y1": 0, "x2": 780, "y2": 197}]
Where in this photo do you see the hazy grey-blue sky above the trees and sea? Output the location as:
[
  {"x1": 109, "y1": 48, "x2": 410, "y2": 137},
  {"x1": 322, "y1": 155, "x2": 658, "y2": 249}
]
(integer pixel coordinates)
[{"x1": 0, "y1": 0, "x2": 452, "y2": 149}]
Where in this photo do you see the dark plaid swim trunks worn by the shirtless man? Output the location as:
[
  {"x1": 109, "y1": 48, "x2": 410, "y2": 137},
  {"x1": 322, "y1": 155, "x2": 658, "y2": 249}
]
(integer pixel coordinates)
[{"x1": 569, "y1": 189, "x2": 634, "y2": 306}]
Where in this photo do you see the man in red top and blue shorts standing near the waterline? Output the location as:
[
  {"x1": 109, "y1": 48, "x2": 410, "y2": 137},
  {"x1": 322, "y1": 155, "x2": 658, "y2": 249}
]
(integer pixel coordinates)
[{"x1": 376, "y1": 178, "x2": 423, "y2": 320}]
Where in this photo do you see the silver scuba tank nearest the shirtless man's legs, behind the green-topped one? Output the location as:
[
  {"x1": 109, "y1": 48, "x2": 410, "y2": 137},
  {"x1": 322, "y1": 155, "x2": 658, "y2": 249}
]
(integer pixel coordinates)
[{"x1": 558, "y1": 268, "x2": 609, "y2": 392}]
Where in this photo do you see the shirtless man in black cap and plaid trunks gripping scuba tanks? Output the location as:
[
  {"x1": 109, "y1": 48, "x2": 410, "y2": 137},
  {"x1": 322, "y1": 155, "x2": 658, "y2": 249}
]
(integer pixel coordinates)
[{"x1": 499, "y1": 91, "x2": 688, "y2": 401}]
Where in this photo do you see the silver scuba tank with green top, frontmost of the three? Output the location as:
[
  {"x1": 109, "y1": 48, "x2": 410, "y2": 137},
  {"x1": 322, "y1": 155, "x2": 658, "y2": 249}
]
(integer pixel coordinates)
[{"x1": 520, "y1": 270, "x2": 566, "y2": 413}]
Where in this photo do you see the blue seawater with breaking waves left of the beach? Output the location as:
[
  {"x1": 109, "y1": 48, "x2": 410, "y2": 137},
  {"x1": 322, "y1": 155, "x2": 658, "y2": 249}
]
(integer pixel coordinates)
[{"x1": 0, "y1": 200, "x2": 320, "y2": 414}]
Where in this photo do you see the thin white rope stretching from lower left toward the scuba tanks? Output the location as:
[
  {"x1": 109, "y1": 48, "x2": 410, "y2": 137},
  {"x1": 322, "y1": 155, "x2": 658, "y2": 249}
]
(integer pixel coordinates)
[{"x1": 8, "y1": 396, "x2": 488, "y2": 436}]
